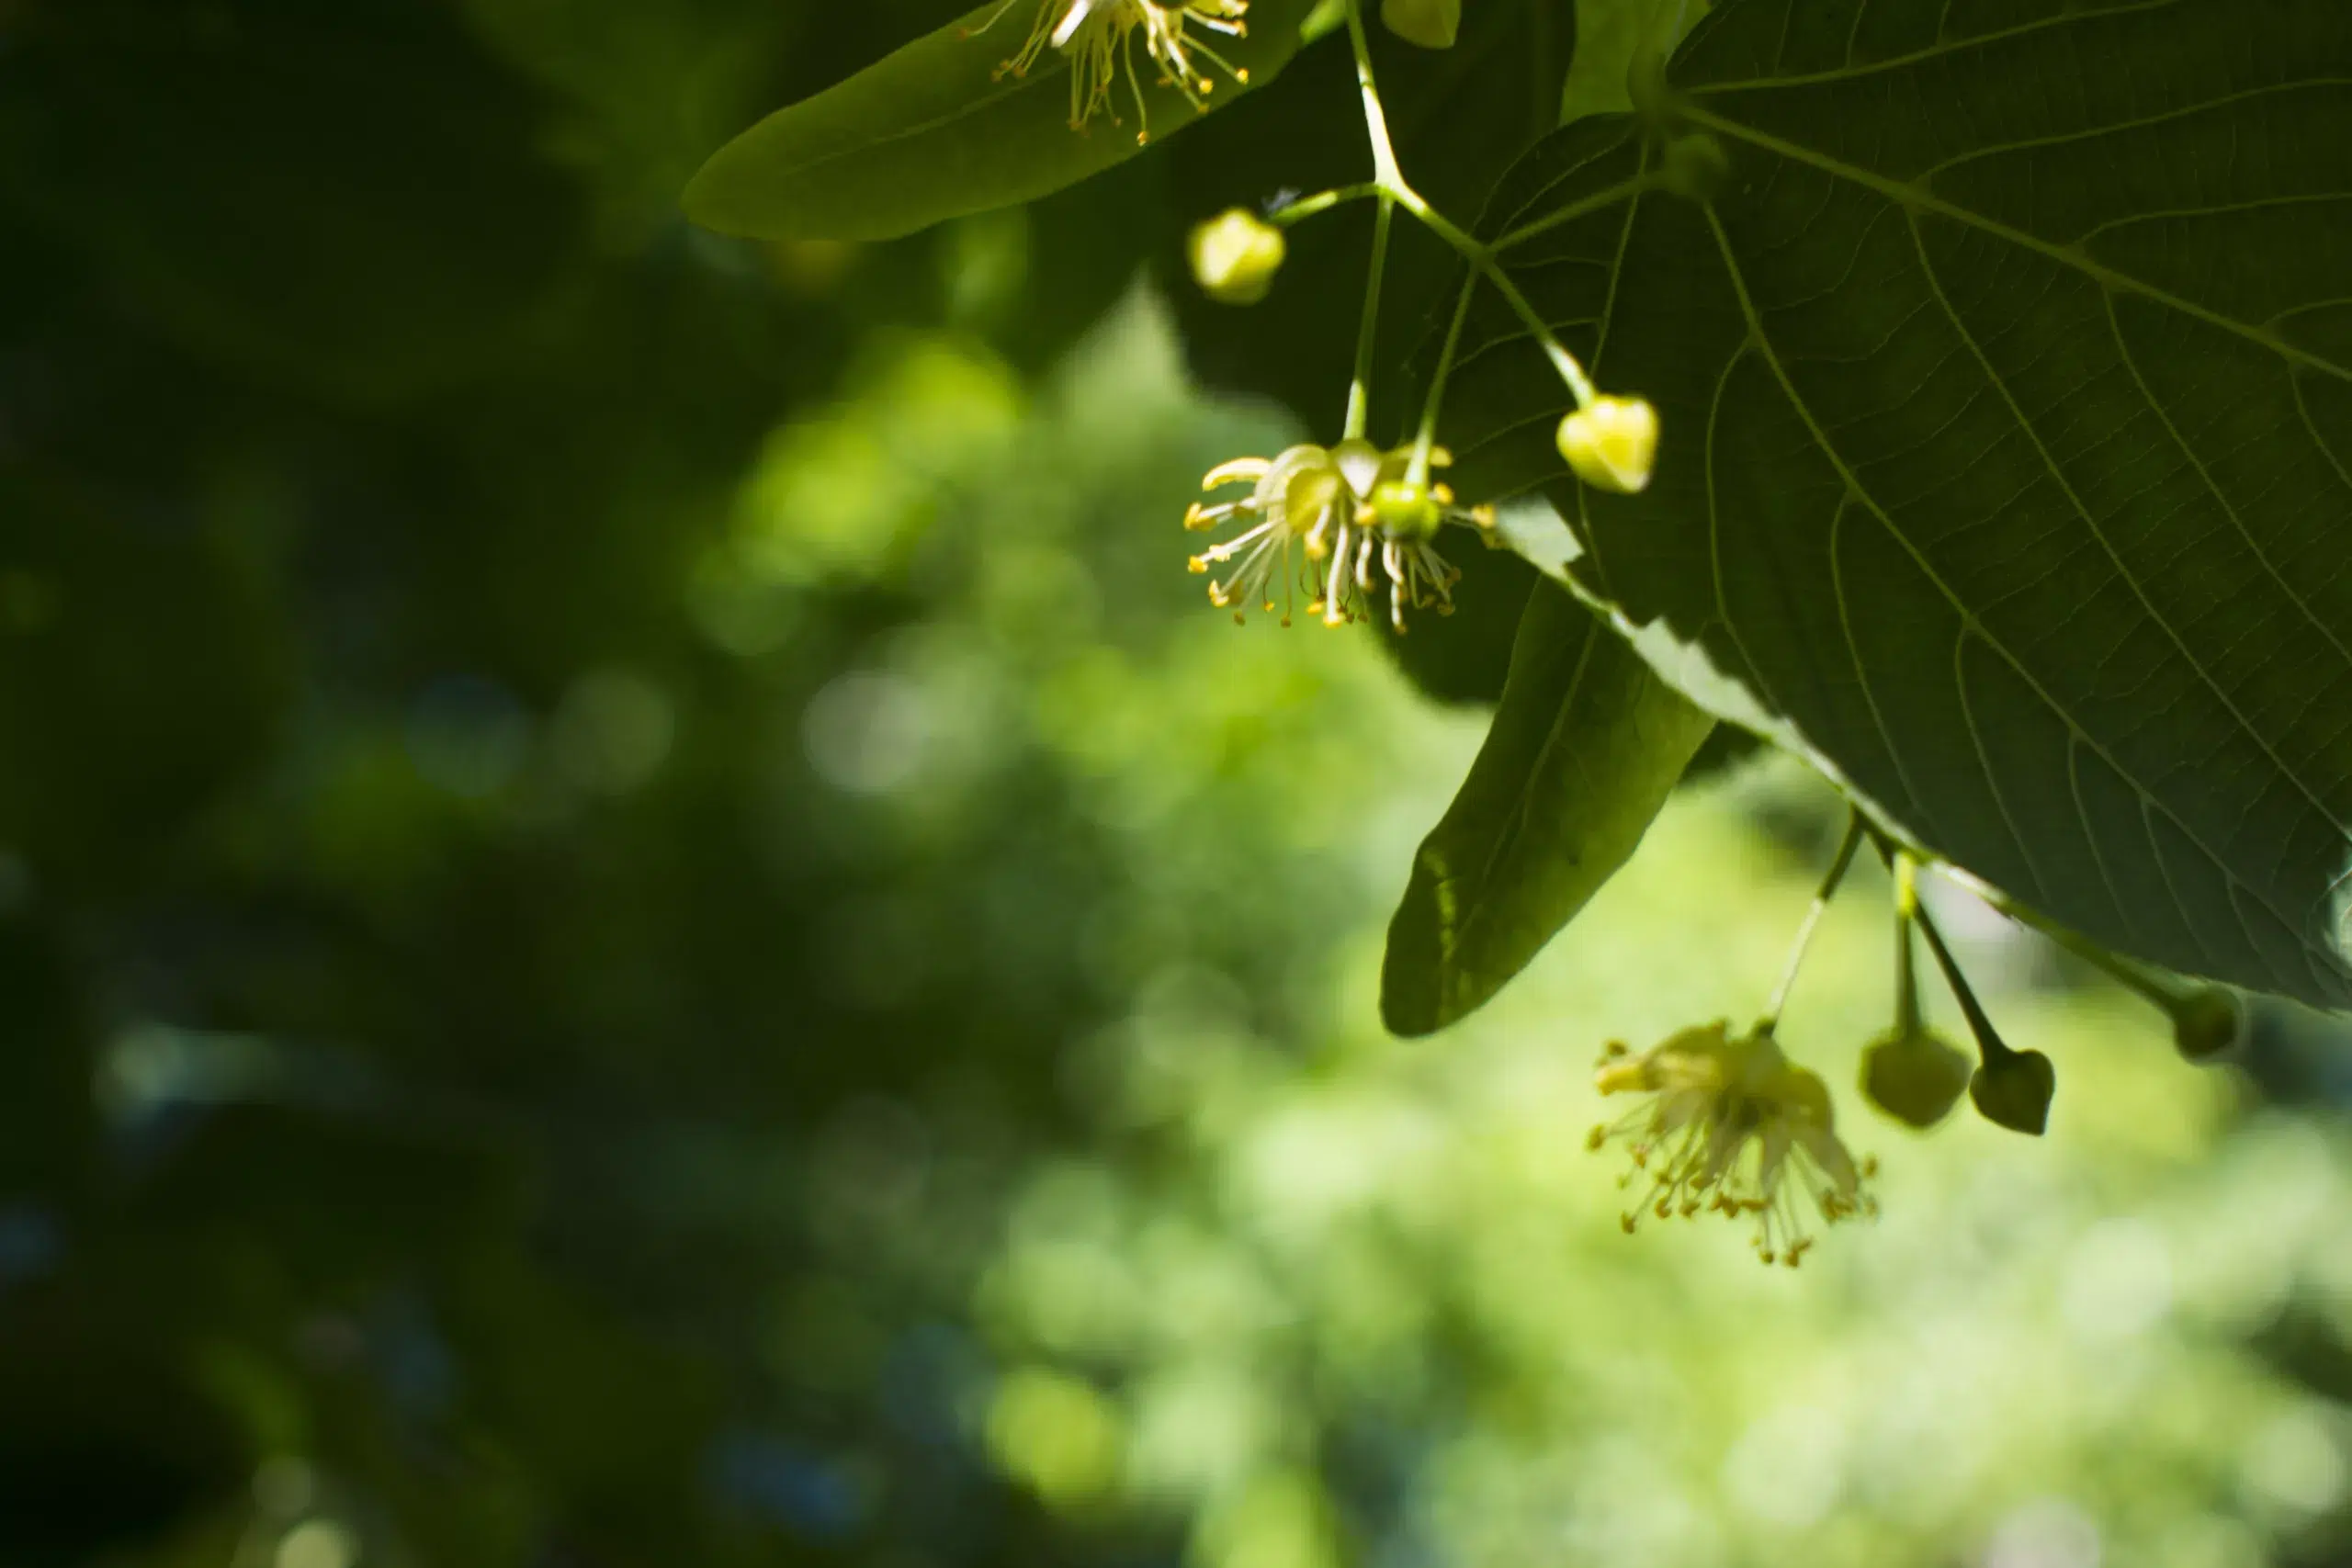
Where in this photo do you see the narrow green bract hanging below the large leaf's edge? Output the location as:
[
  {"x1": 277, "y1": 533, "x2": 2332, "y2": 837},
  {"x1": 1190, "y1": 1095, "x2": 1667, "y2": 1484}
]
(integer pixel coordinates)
[{"x1": 1381, "y1": 588, "x2": 1714, "y2": 1034}]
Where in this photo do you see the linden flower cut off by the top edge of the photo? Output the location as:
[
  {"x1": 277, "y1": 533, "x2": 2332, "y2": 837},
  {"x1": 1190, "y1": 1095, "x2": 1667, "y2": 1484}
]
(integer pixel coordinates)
[{"x1": 969, "y1": 0, "x2": 1249, "y2": 141}]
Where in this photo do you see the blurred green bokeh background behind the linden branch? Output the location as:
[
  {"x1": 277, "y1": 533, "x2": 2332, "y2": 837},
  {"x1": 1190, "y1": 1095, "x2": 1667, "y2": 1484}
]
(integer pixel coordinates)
[{"x1": 14, "y1": 0, "x2": 2352, "y2": 1568}]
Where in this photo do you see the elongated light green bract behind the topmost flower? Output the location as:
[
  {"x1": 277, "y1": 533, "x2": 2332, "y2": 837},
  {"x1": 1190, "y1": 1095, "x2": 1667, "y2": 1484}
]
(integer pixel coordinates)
[{"x1": 684, "y1": 0, "x2": 1312, "y2": 240}]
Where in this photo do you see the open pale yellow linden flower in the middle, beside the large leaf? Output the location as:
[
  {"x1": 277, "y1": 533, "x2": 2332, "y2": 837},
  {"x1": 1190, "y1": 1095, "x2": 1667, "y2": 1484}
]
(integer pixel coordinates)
[{"x1": 1183, "y1": 440, "x2": 1494, "y2": 632}]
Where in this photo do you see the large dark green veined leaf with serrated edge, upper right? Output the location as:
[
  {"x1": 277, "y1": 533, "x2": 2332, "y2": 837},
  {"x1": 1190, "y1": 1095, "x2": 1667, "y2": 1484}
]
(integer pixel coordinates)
[{"x1": 1446, "y1": 0, "x2": 2352, "y2": 1004}]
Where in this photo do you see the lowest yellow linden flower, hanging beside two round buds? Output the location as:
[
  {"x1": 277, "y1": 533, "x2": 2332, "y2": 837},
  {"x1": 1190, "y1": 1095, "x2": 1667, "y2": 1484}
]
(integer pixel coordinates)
[{"x1": 1588, "y1": 1022, "x2": 1877, "y2": 1267}]
